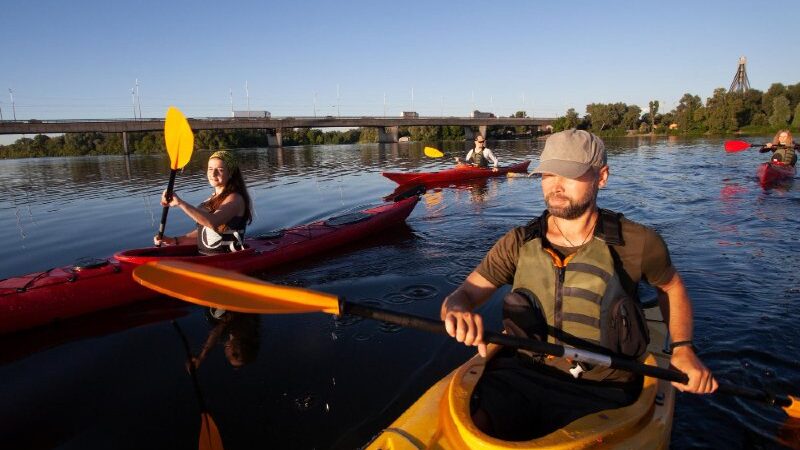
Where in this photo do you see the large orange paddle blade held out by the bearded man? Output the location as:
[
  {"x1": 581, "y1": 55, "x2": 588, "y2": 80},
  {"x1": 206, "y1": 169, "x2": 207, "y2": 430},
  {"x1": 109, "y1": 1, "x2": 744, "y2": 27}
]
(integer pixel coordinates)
[{"x1": 133, "y1": 261, "x2": 339, "y2": 314}]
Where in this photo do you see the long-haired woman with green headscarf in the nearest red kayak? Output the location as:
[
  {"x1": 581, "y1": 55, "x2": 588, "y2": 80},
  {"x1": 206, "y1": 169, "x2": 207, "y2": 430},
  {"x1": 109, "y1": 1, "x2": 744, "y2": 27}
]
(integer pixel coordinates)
[{"x1": 153, "y1": 150, "x2": 253, "y2": 255}]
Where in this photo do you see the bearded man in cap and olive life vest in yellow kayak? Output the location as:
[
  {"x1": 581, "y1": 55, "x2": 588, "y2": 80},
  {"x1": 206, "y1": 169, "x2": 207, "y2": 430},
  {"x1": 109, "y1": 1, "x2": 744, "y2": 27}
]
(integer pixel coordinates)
[{"x1": 441, "y1": 130, "x2": 717, "y2": 440}]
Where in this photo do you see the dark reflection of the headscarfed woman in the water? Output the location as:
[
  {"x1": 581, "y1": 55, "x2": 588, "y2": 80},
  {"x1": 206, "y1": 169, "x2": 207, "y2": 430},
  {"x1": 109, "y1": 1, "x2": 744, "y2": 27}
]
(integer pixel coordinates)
[{"x1": 187, "y1": 309, "x2": 261, "y2": 369}]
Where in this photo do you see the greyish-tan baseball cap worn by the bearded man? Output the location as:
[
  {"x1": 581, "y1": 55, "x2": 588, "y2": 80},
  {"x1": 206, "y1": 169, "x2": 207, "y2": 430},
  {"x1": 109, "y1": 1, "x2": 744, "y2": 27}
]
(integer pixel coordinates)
[{"x1": 533, "y1": 130, "x2": 606, "y2": 179}]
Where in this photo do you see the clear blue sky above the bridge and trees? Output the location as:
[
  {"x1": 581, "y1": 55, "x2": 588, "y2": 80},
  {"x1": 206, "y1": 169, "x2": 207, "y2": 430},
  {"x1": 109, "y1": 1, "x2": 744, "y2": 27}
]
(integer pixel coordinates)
[{"x1": 0, "y1": 0, "x2": 800, "y2": 124}]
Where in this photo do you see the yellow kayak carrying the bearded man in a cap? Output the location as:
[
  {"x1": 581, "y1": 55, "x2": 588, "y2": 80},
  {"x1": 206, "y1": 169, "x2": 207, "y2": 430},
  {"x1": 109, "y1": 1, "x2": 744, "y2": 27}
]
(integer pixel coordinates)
[{"x1": 366, "y1": 308, "x2": 675, "y2": 450}]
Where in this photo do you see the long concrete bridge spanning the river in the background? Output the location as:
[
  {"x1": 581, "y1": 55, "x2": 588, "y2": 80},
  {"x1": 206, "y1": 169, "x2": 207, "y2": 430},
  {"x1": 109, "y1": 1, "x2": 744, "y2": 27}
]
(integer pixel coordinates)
[{"x1": 0, "y1": 116, "x2": 555, "y2": 149}]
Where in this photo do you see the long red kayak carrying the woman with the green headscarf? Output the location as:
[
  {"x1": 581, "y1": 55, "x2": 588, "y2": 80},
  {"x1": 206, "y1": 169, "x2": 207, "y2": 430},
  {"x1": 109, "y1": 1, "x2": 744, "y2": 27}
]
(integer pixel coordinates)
[{"x1": 0, "y1": 193, "x2": 419, "y2": 333}]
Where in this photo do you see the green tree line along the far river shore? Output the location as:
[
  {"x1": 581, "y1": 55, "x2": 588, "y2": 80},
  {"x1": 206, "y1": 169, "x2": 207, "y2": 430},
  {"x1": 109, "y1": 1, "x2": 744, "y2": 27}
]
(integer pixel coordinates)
[{"x1": 0, "y1": 83, "x2": 800, "y2": 159}]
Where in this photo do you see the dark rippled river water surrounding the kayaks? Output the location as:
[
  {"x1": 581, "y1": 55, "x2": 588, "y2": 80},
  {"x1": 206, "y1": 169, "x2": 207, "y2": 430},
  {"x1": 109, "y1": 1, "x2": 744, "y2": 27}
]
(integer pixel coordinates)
[{"x1": 0, "y1": 139, "x2": 800, "y2": 449}]
